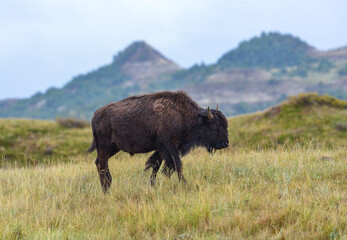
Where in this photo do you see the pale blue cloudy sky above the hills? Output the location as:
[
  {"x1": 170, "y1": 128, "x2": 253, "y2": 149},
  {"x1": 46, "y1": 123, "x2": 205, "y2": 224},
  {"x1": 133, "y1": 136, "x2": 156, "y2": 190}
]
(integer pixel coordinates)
[{"x1": 0, "y1": 0, "x2": 347, "y2": 99}]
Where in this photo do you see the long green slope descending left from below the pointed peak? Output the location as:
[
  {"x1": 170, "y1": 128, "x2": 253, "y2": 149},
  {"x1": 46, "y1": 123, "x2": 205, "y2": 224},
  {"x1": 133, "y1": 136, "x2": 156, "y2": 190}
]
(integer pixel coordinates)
[{"x1": 0, "y1": 63, "x2": 127, "y2": 119}]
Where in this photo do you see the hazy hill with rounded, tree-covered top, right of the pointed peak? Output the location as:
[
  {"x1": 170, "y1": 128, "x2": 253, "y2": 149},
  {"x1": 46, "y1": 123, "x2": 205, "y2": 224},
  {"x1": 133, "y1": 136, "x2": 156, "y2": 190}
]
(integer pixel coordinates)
[{"x1": 177, "y1": 33, "x2": 347, "y2": 115}]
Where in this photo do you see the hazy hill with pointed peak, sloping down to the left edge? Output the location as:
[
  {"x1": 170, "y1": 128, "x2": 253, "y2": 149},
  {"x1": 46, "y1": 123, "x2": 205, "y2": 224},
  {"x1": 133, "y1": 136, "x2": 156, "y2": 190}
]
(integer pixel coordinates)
[{"x1": 0, "y1": 42, "x2": 180, "y2": 119}]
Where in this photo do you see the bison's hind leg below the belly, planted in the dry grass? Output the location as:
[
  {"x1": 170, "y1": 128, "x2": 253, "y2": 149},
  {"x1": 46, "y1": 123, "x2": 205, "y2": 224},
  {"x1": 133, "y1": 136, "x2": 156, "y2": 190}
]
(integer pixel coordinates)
[{"x1": 95, "y1": 152, "x2": 112, "y2": 193}]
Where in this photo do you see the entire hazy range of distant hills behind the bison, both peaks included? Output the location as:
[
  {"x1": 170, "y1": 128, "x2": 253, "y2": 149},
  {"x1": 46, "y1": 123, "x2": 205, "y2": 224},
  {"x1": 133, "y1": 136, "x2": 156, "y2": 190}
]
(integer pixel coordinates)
[{"x1": 0, "y1": 33, "x2": 347, "y2": 119}]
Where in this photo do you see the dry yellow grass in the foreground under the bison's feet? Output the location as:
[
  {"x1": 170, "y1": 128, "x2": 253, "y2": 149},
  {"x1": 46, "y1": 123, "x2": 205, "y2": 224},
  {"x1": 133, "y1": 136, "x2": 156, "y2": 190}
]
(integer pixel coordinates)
[{"x1": 0, "y1": 147, "x2": 347, "y2": 239}]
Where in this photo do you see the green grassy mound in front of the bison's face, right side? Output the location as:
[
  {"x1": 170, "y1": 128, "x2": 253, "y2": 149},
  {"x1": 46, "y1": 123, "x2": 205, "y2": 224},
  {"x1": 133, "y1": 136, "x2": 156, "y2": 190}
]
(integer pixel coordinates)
[{"x1": 229, "y1": 93, "x2": 347, "y2": 148}]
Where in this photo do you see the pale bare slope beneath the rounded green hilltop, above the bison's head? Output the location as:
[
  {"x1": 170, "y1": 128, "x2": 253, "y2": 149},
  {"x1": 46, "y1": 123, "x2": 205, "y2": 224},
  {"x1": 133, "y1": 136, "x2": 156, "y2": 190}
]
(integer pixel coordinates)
[{"x1": 185, "y1": 69, "x2": 305, "y2": 106}]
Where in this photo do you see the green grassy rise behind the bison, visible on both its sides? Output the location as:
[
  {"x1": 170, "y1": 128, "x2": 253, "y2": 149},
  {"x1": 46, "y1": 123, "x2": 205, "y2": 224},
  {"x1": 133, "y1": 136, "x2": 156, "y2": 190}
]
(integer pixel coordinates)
[{"x1": 0, "y1": 94, "x2": 347, "y2": 166}]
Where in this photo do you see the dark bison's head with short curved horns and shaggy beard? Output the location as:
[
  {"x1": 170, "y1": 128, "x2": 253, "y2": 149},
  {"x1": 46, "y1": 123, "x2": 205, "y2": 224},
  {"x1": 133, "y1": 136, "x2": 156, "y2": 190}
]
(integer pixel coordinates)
[{"x1": 199, "y1": 106, "x2": 229, "y2": 152}]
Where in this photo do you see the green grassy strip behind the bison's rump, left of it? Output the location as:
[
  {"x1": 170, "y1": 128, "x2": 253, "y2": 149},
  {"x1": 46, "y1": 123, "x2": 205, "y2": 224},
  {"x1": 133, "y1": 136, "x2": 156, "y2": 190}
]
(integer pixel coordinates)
[{"x1": 0, "y1": 119, "x2": 92, "y2": 167}]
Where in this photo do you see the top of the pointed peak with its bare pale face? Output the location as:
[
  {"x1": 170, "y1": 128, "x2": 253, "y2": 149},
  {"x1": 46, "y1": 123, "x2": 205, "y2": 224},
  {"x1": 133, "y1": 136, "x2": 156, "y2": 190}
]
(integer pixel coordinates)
[{"x1": 115, "y1": 42, "x2": 181, "y2": 88}]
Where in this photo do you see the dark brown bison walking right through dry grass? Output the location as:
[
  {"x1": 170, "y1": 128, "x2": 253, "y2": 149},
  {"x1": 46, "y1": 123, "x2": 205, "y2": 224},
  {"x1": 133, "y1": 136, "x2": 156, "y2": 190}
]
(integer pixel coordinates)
[{"x1": 87, "y1": 91, "x2": 229, "y2": 193}]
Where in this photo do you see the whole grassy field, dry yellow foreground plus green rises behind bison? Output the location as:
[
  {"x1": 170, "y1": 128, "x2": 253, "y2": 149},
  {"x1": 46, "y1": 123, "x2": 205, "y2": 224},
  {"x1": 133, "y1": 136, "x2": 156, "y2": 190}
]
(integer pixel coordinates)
[{"x1": 0, "y1": 95, "x2": 347, "y2": 239}]
